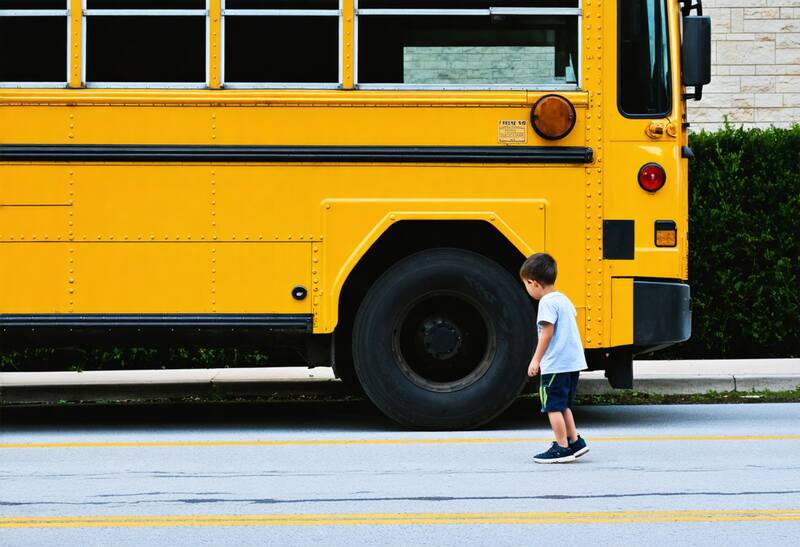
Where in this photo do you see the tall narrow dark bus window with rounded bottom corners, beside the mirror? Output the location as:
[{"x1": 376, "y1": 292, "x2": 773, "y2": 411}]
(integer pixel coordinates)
[{"x1": 617, "y1": 0, "x2": 672, "y2": 118}]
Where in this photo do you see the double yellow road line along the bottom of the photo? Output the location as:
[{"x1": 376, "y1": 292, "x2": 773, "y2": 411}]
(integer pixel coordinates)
[{"x1": 0, "y1": 509, "x2": 800, "y2": 528}]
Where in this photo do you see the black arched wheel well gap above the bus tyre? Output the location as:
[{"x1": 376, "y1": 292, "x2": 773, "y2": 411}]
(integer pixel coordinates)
[{"x1": 337, "y1": 220, "x2": 525, "y2": 340}]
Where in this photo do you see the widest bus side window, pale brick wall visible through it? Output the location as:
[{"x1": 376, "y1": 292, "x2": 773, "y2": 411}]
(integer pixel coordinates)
[{"x1": 357, "y1": 0, "x2": 580, "y2": 89}]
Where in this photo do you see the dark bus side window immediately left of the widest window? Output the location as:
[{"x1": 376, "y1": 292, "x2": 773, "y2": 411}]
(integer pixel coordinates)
[{"x1": 222, "y1": 0, "x2": 341, "y2": 88}]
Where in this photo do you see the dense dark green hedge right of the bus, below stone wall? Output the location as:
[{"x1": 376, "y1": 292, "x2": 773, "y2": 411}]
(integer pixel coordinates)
[{"x1": 660, "y1": 125, "x2": 800, "y2": 358}]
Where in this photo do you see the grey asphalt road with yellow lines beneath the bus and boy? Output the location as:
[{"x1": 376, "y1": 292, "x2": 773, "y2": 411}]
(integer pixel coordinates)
[{"x1": 0, "y1": 401, "x2": 800, "y2": 546}]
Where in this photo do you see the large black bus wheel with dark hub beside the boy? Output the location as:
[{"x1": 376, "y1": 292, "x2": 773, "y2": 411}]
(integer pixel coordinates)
[{"x1": 353, "y1": 248, "x2": 535, "y2": 429}]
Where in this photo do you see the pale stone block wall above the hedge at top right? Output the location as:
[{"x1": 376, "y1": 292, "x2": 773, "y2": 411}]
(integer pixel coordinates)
[{"x1": 689, "y1": 0, "x2": 800, "y2": 130}]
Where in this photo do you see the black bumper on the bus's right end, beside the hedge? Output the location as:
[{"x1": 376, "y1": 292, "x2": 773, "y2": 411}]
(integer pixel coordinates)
[{"x1": 633, "y1": 280, "x2": 692, "y2": 353}]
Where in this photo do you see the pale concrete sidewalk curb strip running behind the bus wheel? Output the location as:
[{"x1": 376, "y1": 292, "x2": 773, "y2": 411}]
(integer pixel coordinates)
[{"x1": 0, "y1": 359, "x2": 800, "y2": 404}]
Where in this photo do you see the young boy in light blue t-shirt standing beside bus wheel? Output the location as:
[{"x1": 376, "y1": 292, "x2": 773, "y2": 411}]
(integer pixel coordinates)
[{"x1": 519, "y1": 253, "x2": 589, "y2": 463}]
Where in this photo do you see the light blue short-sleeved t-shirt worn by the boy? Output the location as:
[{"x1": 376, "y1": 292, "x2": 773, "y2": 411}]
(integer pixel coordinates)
[{"x1": 536, "y1": 291, "x2": 587, "y2": 374}]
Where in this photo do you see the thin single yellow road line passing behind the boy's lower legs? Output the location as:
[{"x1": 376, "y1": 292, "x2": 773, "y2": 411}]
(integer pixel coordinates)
[{"x1": 0, "y1": 435, "x2": 800, "y2": 449}]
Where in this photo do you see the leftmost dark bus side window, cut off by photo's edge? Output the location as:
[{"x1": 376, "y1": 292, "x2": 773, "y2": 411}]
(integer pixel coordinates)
[{"x1": 0, "y1": 0, "x2": 68, "y2": 87}]
